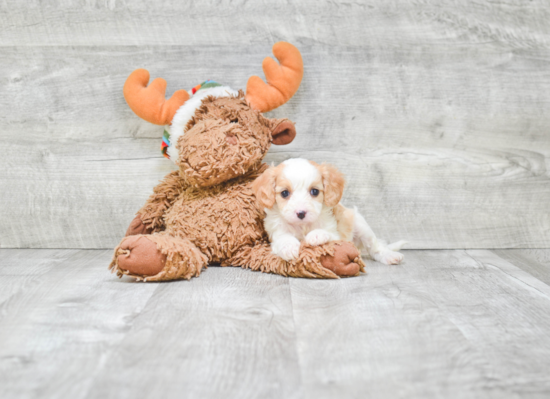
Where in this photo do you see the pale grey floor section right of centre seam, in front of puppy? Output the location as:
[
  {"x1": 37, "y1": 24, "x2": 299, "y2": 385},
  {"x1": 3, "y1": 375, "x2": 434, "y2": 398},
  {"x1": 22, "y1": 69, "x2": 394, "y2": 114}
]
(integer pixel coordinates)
[{"x1": 290, "y1": 251, "x2": 550, "y2": 398}]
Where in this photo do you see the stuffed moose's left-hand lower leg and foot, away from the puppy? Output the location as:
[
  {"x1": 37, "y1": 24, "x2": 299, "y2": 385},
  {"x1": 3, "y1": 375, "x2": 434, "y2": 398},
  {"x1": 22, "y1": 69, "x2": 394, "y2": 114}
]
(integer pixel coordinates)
[{"x1": 109, "y1": 233, "x2": 208, "y2": 281}]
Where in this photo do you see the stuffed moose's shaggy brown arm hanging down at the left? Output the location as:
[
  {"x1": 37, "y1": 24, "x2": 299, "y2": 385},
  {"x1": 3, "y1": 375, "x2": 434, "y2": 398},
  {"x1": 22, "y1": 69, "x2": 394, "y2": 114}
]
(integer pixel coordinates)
[{"x1": 126, "y1": 170, "x2": 185, "y2": 236}]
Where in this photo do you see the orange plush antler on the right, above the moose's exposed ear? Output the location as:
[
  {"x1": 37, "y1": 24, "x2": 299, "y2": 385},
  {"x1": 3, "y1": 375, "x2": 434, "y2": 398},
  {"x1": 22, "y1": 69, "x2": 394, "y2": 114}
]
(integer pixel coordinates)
[{"x1": 246, "y1": 42, "x2": 304, "y2": 112}]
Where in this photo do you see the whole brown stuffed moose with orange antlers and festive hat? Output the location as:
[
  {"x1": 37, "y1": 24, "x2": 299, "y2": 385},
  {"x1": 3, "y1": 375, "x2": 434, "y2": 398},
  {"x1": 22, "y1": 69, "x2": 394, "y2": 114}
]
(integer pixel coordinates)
[{"x1": 110, "y1": 42, "x2": 364, "y2": 281}]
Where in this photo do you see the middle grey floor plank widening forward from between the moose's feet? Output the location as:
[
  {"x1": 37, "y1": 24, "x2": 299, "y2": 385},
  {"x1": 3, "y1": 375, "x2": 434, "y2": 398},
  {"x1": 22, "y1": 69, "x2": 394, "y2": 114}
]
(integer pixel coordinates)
[{"x1": 89, "y1": 267, "x2": 303, "y2": 398}]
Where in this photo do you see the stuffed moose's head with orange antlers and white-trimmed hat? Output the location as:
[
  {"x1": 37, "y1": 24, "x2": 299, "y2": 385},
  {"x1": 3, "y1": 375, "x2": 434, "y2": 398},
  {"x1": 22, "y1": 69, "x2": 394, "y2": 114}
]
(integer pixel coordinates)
[{"x1": 124, "y1": 42, "x2": 303, "y2": 187}]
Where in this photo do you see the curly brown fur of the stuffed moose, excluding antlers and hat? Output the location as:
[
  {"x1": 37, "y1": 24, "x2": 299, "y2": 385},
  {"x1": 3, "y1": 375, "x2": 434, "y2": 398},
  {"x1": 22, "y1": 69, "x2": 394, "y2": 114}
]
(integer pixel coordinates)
[{"x1": 110, "y1": 92, "x2": 363, "y2": 281}]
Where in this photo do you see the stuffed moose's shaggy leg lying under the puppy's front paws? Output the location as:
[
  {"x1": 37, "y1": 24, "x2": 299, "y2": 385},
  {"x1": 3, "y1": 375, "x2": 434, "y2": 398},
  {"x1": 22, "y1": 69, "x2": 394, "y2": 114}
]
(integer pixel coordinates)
[{"x1": 229, "y1": 241, "x2": 364, "y2": 278}]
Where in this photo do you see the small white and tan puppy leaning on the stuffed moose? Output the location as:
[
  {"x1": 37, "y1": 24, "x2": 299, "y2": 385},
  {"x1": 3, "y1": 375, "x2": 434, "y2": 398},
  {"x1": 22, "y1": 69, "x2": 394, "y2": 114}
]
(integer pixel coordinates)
[{"x1": 252, "y1": 158, "x2": 406, "y2": 265}]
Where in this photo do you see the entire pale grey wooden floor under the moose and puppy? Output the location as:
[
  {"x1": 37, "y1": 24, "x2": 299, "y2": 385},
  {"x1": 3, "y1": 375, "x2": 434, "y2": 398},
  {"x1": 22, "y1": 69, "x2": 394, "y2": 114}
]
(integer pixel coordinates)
[{"x1": 0, "y1": 249, "x2": 550, "y2": 399}]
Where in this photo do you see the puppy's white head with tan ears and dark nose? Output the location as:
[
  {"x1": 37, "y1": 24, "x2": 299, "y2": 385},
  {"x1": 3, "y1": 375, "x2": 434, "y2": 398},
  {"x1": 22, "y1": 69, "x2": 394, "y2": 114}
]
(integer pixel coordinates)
[{"x1": 253, "y1": 158, "x2": 345, "y2": 225}]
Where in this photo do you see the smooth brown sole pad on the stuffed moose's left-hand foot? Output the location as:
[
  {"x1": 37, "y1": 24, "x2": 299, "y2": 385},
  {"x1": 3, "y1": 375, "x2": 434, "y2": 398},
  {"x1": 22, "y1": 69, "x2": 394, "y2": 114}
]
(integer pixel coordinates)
[{"x1": 117, "y1": 235, "x2": 166, "y2": 276}]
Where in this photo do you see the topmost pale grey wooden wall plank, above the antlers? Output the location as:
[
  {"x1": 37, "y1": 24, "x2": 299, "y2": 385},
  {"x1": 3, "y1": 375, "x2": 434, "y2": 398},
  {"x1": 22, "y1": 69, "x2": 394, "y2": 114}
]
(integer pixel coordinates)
[{"x1": 0, "y1": 0, "x2": 550, "y2": 48}]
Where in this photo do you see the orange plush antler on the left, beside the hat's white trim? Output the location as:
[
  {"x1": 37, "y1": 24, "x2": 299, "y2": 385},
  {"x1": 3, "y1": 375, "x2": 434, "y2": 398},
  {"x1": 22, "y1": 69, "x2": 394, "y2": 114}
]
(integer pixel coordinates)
[{"x1": 123, "y1": 69, "x2": 189, "y2": 125}]
